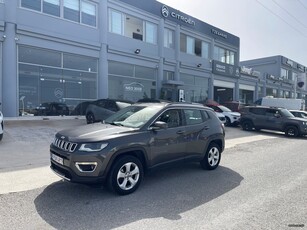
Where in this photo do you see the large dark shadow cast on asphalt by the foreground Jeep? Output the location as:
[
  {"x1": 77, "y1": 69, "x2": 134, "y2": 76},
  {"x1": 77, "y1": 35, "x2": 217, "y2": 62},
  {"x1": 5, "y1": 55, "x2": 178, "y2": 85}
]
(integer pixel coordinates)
[{"x1": 34, "y1": 163, "x2": 244, "y2": 230}]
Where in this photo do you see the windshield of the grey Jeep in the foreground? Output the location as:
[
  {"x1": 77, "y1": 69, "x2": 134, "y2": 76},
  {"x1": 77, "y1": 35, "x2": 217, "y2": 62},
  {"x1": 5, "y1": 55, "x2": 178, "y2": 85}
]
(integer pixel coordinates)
[{"x1": 105, "y1": 105, "x2": 162, "y2": 128}]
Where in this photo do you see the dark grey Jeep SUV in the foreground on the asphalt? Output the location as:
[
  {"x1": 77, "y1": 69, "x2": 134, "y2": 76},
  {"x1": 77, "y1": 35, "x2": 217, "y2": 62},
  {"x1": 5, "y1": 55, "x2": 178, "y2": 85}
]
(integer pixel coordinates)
[{"x1": 50, "y1": 103, "x2": 225, "y2": 195}]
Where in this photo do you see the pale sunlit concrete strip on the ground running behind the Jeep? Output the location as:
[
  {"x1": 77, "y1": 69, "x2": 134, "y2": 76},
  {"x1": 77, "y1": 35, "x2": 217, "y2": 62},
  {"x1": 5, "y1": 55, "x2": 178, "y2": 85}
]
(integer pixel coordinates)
[{"x1": 0, "y1": 135, "x2": 276, "y2": 194}]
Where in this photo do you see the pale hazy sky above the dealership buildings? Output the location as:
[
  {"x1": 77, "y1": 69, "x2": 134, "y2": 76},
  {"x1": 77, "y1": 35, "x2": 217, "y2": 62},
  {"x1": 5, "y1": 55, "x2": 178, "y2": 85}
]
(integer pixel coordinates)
[{"x1": 159, "y1": 0, "x2": 307, "y2": 66}]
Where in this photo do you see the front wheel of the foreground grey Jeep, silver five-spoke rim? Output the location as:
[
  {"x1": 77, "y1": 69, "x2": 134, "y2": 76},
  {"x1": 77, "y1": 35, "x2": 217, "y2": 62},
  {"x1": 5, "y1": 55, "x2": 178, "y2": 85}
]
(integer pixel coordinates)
[{"x1": 108, "y1": 156, "x2": 144, "y2": 195}]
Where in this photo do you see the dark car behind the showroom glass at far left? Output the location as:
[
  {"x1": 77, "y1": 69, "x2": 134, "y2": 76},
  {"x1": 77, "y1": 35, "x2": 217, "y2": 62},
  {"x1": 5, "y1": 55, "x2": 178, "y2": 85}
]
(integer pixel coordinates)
[{"x1": 34, "y1": 102, "x2": 69, "y2": 116}]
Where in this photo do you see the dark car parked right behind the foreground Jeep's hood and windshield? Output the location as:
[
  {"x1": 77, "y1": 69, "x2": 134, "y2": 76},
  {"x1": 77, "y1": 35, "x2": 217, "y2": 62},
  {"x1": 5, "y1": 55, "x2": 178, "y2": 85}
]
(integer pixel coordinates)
[{"x1": 86, "y1": 99, "x2": 133, "y2": 124}]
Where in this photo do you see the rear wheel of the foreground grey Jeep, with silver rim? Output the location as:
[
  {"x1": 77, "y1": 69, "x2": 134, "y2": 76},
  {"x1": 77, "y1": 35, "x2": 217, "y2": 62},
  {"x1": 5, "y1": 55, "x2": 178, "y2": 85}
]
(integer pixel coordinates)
[{"x1": 200, "y1": 143, "x2": 221, "y2": 170}]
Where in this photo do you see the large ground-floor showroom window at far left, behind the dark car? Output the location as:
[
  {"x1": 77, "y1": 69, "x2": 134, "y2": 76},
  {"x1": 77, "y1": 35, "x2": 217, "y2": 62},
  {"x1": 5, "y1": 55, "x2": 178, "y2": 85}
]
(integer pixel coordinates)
[{"x1": 18, "y1": 46, "x2": 98, "y2": 115}]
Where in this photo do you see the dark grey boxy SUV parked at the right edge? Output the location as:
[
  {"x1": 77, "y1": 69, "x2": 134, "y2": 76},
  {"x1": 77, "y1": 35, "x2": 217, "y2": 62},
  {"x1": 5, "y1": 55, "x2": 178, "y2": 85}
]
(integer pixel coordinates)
[{"x1": 240, "y1": 106, "x2": 307, "y2": 137}]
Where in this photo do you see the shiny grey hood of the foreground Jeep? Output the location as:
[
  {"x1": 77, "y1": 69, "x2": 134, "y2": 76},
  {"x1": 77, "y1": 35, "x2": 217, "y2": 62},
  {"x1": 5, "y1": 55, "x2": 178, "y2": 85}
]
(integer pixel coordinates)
[{"x1": 56, "y1": 123, "x2": 136, "y2": 142}]
